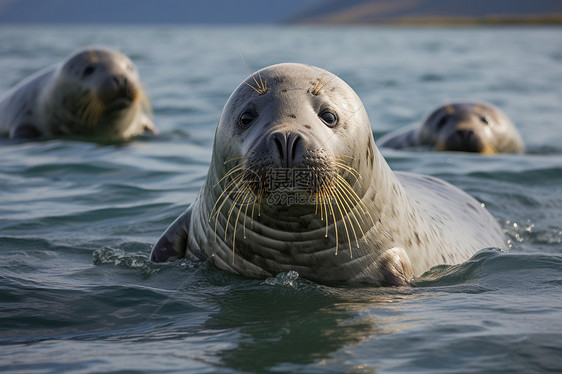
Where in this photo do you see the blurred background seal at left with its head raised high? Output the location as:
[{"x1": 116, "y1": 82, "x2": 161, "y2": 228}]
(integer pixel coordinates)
[{"x1": 0, "y1": 48, "x2": 156, "y2": 140}]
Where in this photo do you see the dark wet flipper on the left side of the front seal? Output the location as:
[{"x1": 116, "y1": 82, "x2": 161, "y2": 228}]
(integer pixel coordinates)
[{"x1": 150, "y1": 207, "x2": 191, "y2": 262}]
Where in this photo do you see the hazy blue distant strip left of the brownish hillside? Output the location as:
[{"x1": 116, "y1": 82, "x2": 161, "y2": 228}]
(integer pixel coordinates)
[{"x1": 0, "y1": 0, "x2": 321, "y2": 24}]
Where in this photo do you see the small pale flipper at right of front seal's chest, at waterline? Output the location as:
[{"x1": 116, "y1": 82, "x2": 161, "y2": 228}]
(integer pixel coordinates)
[{"x1": 378, "y1": 247, "x2": 413, "y2": 286}]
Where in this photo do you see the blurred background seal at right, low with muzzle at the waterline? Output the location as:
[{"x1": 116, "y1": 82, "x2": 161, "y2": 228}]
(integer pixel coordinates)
[{"x1": 377, "y1": 102, "x2": 525, "y2": 154}]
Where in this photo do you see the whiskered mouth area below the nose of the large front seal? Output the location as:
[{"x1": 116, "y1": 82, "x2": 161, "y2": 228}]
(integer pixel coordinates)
[{"x1": 209, "y1": 157, "x2": 374, "y2": 257}]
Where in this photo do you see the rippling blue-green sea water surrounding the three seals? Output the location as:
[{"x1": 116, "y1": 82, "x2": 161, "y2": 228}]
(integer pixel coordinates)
[{"x1": 0, "y1": 25, "x2": 562, "y2": 373}]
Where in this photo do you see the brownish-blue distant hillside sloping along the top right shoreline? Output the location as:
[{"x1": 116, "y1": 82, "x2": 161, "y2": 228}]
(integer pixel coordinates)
[{"x1": 290, "y1": 0, "x2": 562, "y2": 24}]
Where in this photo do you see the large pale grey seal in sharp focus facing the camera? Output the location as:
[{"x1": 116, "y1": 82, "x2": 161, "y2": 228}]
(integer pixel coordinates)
[{"x1": 150, "y1": 64, "x2": 506, "y2": 285}]
